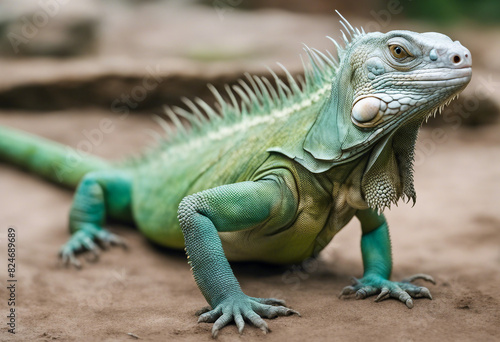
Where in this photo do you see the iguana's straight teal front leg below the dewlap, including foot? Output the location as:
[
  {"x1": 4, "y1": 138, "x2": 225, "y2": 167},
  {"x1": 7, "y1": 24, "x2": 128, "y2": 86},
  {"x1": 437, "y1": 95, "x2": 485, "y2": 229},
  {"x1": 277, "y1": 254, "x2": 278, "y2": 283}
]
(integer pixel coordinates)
[{"x1": 340, "y1": 209, "x2": 435, "y2": 309}]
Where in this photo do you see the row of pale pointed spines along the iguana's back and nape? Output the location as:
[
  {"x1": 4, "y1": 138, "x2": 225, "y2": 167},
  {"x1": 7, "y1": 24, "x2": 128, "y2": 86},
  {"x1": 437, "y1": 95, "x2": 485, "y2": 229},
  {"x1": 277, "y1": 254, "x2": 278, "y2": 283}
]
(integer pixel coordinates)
[{"x1": 128, "y1": 11, "x2": 365, "y2": 162}]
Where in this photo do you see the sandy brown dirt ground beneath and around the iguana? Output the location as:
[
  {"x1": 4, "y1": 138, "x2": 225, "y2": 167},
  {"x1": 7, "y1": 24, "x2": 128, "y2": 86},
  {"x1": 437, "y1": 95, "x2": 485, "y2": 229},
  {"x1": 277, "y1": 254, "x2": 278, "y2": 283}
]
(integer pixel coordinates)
[{"x1": 0, "y1": 111, "x2": 500, "y2": 341}]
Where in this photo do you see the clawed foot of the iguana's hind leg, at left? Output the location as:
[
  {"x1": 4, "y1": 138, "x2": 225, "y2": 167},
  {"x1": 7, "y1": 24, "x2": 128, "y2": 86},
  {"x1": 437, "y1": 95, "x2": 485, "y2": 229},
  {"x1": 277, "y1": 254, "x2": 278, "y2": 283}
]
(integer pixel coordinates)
[{"x1": 59, "y1": 225, "x2": 127, "y2": 268}]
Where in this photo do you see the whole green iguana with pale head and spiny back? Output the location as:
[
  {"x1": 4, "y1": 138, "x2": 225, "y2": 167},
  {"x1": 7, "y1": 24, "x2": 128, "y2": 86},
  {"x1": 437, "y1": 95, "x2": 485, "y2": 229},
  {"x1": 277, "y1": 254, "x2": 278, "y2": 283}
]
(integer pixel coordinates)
[{"x1": 0, "y1": 17, "x2": 472, "y2": 337}]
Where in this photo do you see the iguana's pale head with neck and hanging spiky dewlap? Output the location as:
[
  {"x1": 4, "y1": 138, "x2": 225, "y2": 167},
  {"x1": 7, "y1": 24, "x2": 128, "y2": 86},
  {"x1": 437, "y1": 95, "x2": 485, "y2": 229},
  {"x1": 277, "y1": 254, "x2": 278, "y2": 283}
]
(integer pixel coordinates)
[{"x1": 303, "y1": 23, "x2": 472, "y2": 210}]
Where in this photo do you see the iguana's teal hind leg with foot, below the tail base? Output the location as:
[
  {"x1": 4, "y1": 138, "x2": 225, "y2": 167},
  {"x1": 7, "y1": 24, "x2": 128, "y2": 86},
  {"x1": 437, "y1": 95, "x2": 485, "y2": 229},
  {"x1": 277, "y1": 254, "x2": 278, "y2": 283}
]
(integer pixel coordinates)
[{"x1": 59, "y1": 170, "x2": 132, "y2": 267}]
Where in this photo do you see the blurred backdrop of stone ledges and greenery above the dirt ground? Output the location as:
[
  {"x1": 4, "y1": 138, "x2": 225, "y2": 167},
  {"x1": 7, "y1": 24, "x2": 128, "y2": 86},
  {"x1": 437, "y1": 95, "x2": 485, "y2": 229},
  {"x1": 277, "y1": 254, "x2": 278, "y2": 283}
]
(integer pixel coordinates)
[{"x1": 0, "y1": 0, "x2": 500, "y2": 124}]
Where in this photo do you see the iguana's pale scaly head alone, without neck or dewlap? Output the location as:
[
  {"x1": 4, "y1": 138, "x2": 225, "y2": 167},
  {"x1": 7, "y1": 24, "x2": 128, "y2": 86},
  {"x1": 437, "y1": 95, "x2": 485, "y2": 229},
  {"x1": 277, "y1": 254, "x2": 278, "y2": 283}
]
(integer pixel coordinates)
[{"x1": 348, "y1": 31, "x2": 472, "y2": 129}]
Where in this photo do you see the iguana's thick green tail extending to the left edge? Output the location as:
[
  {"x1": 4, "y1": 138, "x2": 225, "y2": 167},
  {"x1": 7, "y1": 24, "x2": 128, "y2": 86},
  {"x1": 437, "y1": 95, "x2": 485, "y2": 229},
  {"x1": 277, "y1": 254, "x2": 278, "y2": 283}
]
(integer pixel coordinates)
[{"x1": 0, "y1": 126, "x2": 111, "y2": 188}]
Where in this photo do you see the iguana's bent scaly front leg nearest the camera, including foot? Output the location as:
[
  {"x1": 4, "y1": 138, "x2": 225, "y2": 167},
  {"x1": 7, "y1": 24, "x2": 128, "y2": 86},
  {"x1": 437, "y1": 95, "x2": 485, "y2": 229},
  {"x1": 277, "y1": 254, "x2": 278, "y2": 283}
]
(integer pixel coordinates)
[{"x1": 178, "y1": 177, "x2": 298, "y2": 337}]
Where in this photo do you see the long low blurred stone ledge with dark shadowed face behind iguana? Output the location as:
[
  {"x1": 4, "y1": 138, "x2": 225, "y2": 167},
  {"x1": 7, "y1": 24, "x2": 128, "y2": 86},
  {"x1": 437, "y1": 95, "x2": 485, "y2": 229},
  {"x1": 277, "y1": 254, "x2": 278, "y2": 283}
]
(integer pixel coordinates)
[{"x1": 0, "y1": 59, "x2": 297, "y2": 113}]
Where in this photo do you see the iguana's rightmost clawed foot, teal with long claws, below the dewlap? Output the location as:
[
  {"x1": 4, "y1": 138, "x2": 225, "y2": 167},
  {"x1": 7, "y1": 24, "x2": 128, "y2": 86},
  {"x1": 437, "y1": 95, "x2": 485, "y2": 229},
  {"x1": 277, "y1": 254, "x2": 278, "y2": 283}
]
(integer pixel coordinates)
[{"x1": 339, "y1": 274, "x2": 436, "y2": 309}]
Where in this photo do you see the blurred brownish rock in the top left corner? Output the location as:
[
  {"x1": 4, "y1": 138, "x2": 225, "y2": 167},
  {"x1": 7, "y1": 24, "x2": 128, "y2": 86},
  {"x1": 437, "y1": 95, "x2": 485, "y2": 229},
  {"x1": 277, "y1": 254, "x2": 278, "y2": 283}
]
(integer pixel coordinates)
[{"x1": 0, "y1": 0, "x2": 100, "y2": 57}]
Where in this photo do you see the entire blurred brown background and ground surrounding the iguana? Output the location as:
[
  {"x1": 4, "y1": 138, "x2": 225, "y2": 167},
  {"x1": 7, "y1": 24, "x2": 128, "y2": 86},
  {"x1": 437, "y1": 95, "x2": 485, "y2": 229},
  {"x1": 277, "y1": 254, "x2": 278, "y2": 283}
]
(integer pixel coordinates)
[{"x1": 0, "y1": 0, "x2": 500, "y2": 341}]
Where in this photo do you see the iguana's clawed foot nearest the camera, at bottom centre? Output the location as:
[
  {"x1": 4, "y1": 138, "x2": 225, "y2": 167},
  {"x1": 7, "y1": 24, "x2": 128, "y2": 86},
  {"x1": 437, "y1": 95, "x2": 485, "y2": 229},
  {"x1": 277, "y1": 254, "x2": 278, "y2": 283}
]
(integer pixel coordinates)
[{"x1": 196, "y1": 293, "x2": 300, "y2": 338}]
